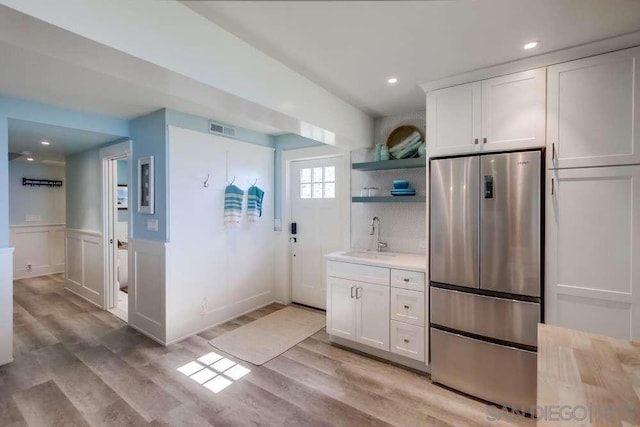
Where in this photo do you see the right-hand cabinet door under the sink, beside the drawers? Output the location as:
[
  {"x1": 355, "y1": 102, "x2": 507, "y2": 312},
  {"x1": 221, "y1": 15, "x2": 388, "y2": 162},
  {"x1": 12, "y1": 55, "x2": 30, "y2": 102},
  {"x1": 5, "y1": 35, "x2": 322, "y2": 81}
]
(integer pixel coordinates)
[{"x1": 356, "y1": 283, "x2": 389, "y2": 351}]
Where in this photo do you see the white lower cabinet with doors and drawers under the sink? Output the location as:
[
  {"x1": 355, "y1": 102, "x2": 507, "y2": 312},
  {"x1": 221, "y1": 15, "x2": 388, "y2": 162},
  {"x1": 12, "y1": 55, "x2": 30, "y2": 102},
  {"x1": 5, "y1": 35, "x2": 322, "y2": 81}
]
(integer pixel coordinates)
[{"x1": 327, "y1": 261, "x2": 427, "y2": 367}]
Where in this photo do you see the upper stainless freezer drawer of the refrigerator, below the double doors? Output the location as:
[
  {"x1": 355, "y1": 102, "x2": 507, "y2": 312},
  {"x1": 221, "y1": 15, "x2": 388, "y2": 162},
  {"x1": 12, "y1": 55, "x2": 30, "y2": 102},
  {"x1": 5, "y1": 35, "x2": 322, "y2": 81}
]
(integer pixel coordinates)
[{"x1": 429, "y1": 286, "x2": 540, "y2": 347}]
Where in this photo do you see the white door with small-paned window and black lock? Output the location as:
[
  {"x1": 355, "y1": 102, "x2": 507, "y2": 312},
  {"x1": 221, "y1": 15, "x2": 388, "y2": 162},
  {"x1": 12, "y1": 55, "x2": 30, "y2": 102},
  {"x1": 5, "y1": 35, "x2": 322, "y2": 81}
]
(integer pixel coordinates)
[{"x1": 289, "y1": 156, "x2": 348, "y2": 309}]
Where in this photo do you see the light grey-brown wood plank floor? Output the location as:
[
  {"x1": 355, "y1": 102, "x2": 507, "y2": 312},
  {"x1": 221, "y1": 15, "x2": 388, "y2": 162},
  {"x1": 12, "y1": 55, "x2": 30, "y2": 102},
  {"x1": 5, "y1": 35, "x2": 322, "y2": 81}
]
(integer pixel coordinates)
[{"x1": 0, "y1": 275, "x2": 533, "y2": 426}]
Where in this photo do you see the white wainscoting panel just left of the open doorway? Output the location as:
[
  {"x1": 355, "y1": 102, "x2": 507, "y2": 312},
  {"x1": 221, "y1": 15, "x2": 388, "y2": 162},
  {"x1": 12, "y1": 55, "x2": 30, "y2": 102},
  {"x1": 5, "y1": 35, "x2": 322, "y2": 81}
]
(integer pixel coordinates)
[{"x1": 66, "y1": 229, "x2": 104, "y2": 308}]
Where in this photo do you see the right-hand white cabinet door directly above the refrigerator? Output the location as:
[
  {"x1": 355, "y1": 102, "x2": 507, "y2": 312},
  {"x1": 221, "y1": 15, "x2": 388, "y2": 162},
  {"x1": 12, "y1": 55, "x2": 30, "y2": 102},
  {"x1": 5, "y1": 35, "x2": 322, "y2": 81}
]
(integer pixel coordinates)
[{"x1": 482, "y1": 68, "x2": 546, "y2": 150}]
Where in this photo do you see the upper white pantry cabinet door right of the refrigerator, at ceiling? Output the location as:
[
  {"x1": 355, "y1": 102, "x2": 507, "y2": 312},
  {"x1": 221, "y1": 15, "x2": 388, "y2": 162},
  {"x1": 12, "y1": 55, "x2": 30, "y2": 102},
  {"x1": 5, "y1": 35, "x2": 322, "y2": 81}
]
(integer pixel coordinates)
[{"x1": 547, "y1": 48, "x2": 640, "y2": 168}]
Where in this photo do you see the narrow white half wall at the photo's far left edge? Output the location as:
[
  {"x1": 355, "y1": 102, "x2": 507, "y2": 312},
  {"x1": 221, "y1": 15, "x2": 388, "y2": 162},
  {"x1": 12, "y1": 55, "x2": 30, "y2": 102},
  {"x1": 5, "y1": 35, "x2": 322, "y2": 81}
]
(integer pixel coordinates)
[{"x1": 0, "y1": 248, "x2": 13, "y2": 365}]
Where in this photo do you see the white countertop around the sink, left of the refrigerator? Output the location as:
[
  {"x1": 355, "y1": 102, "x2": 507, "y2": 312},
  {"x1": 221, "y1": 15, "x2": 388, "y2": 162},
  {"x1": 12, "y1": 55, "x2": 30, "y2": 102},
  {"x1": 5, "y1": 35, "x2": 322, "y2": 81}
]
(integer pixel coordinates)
[{"x1": 325, "y1": 249, "x2": 427, "y2": 271}]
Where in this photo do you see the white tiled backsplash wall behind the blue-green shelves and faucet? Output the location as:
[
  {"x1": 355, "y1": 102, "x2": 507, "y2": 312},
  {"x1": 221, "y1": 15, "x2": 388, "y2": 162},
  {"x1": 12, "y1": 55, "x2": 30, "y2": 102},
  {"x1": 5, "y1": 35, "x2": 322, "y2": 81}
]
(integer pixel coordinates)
[{"x1": 351, "y1": 111, "x2": 427, "y2": 254}]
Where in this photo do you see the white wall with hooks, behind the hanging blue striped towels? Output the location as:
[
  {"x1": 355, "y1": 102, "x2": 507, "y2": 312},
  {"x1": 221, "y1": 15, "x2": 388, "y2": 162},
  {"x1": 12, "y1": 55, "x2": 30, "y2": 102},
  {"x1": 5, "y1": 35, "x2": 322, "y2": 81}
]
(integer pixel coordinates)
[{"x1": 166, "y1": 126, "x2": 276, "y2": 342}]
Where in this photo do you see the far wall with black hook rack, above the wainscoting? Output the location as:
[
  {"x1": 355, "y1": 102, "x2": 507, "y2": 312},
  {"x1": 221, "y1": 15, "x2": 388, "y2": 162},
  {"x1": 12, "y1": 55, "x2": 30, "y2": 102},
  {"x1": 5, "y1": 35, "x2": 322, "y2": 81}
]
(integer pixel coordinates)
[{"x1": 9, "y1": 161, "x2": 66, "y2": 226}]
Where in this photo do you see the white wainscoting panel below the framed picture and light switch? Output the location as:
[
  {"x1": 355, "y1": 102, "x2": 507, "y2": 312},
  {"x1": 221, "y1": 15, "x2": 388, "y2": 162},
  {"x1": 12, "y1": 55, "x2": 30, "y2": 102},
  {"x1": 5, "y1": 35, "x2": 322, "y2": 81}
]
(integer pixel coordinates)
[{"x1": 129, "y1": 239, "x2": 166, "y2": 343}]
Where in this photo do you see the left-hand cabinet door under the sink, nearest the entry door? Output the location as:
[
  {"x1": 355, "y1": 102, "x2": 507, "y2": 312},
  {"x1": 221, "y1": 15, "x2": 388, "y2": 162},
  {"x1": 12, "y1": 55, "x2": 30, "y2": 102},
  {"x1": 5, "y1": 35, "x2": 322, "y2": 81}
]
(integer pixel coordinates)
[{"x1": 327, "y1": 277, "x2": 359, "y2": 341}]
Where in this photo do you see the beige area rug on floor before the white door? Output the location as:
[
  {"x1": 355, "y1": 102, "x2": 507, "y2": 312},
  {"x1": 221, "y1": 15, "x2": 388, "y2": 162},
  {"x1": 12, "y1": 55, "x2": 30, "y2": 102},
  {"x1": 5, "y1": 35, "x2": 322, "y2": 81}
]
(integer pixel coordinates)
[{"x1": 209, "y1": 307, "x2": 326, "y2": 365}]
